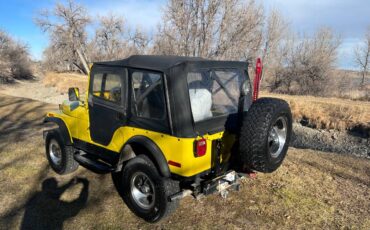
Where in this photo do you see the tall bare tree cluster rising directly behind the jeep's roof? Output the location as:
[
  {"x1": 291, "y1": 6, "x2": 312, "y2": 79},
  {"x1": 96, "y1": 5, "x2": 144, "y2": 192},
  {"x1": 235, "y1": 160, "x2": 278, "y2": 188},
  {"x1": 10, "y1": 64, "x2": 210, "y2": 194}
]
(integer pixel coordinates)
[{"x1": 154, "y1": 0, "x2": 264, "y2": 60}]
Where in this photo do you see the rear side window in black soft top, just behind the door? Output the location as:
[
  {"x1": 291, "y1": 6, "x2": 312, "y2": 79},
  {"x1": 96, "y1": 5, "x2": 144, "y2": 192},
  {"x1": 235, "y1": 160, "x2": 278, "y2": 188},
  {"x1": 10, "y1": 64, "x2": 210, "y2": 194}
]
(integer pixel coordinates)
[{"x1": 131, "y1": 71, "x2": 166, "y2": 119}]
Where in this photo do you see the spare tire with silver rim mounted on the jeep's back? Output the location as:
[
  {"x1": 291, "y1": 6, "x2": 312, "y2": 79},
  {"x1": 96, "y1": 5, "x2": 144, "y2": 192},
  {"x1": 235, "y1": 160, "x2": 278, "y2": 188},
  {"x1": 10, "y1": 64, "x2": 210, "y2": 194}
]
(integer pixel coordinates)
[{"x1": 239, "y1": 98, "x2": 292, "y2": 173}]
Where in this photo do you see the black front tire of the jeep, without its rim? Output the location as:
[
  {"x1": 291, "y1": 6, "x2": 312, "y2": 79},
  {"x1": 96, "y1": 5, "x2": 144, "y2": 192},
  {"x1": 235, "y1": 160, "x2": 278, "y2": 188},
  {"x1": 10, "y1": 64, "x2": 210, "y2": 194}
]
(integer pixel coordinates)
[{"x1": 45, "y1": 130, "x2": 79, "y2": 175}]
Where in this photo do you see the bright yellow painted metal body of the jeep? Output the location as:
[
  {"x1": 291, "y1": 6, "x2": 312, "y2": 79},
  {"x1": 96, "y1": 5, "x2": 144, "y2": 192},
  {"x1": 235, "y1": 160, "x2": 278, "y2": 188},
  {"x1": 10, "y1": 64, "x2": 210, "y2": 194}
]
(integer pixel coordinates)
[{"x1": 47, "y1": 66, "x2": 235, "y2": 177}]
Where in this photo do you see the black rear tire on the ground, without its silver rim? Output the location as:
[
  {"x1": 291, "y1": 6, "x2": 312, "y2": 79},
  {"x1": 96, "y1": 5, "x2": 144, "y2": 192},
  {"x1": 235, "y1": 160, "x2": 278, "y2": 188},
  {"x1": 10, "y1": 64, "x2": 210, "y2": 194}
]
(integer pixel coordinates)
[{"x1": 120, "y1": 155, "x2": 179, "y2": 223}]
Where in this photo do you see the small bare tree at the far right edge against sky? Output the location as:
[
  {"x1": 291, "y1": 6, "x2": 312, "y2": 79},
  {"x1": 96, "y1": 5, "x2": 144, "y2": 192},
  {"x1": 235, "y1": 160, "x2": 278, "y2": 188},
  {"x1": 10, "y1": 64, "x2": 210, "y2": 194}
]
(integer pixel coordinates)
[{"x1": 354, "y1": 27, "x2": 370, "y2": 86}]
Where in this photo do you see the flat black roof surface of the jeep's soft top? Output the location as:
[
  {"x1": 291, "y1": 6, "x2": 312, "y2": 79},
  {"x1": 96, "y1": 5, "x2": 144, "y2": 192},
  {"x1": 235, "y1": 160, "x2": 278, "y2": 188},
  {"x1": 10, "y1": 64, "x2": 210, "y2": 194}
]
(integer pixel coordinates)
[{"x1": 94, "y1": 55, "x2": 246, "y2": 72}]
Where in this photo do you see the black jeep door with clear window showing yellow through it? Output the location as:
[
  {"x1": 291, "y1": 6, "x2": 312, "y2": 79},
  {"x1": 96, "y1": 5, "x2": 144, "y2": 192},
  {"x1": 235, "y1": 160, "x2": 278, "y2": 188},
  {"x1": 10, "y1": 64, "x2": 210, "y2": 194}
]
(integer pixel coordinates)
[{"x1": 88, "y1": 66, "x2": 127, "y2": 146}]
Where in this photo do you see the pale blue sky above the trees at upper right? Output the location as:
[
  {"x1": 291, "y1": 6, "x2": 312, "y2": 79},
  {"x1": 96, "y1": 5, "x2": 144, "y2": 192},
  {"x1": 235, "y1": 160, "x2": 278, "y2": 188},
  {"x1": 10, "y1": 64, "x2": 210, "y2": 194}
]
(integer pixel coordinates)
[{"x1": 260, "y1": 0, "x2": 370, "y2": 69}]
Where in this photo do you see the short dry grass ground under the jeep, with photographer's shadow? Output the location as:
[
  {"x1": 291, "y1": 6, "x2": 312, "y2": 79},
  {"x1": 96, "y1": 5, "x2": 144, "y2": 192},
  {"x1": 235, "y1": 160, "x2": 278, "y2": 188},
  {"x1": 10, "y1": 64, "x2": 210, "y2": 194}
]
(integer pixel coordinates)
[{"x1": 0, "y1": 95, "x2": 370, "y2": 229}]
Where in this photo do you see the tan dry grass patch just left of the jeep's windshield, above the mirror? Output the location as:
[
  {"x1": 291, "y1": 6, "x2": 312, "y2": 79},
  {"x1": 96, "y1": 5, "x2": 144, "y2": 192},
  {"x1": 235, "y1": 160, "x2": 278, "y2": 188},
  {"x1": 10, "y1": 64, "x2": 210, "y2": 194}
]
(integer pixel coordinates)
[{"x1": 43, "y1": 72, "x2": 88, "y2": 93}]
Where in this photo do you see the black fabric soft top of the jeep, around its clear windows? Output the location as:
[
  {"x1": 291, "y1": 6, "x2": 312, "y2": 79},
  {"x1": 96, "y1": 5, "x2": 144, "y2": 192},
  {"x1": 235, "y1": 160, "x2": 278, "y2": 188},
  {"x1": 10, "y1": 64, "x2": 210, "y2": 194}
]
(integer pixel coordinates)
[{"x1": 91, "y1": 55, "x2": 252, "y2": 137}]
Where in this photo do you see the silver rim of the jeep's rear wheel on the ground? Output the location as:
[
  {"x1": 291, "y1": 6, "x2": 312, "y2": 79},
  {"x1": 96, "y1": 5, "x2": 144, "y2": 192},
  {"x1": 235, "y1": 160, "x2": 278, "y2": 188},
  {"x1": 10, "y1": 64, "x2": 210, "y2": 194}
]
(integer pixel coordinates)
[{"x1": 130, "y1": 172, "x2": 155, "y2": 209}]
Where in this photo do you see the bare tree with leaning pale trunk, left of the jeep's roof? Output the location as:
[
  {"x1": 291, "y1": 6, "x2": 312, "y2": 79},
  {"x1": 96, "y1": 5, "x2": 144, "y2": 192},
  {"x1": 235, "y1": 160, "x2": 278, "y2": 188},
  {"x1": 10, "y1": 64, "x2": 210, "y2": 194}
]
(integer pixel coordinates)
[{"x1": 35, "y1": 0, "x2": 90, "y2": 74}]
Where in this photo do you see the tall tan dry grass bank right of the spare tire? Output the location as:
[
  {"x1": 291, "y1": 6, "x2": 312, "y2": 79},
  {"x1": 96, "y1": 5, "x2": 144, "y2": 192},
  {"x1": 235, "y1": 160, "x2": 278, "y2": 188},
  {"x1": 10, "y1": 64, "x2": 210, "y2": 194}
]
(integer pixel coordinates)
[{"x1": 262, "y1": 92, "x2": 370, "y2": 130}]
